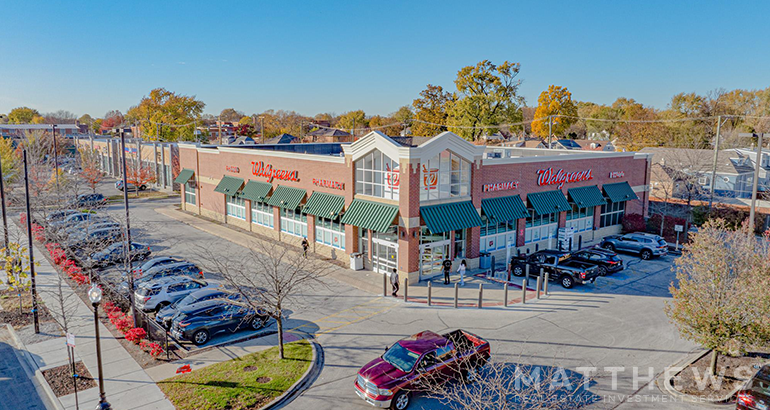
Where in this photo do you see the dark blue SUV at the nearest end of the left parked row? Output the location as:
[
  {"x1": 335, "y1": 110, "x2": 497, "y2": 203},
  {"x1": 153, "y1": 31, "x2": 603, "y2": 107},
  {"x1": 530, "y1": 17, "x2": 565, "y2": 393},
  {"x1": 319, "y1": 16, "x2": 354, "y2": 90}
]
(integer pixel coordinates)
[{"x1": 171, "y1": 299, "x2": 269, "y2": 345}]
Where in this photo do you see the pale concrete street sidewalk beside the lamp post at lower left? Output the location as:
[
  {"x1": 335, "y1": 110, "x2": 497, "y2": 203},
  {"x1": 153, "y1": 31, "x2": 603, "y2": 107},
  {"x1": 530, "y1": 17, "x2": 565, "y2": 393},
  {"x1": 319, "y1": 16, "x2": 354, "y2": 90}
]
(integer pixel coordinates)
[{"x1": 10, "y1": 224, "x2": 174, "y2": 410}]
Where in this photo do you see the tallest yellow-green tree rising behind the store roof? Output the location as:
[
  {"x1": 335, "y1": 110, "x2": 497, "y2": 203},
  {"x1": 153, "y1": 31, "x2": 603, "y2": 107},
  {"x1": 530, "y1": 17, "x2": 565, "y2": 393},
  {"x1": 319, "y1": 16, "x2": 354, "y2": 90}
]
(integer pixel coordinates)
[{"x1": 447, "y1": 60, "x2": 524, "y2": 141}]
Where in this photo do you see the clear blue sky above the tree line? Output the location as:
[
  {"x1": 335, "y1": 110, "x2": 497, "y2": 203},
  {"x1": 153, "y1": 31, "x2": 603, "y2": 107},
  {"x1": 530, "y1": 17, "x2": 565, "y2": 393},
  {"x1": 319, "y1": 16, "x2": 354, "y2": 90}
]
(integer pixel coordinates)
[{"x1": 0, "y1": 0, "x2": 770, "y2": 116}]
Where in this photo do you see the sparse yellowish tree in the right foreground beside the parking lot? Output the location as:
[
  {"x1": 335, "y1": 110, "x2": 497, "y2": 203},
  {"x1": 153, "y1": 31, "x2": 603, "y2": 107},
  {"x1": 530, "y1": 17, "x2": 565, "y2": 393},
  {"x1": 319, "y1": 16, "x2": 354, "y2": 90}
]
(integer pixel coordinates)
[{"x1": 665, "y1": 220, "x2": 770, "y2": 375}]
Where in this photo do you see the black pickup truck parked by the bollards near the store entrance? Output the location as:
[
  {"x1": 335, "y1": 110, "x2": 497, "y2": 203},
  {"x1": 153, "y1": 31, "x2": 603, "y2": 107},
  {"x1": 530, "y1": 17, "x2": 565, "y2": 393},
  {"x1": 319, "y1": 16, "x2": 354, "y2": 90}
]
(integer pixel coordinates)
[{"x1": 511, "y1": 250, "x2": 599, "y2": 289}]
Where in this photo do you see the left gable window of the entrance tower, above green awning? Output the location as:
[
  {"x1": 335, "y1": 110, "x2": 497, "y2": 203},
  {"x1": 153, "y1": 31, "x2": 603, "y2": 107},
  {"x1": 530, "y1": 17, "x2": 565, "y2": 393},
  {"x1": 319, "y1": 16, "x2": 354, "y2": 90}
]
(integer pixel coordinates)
[{"x1": 356, "y1": 150, "x2": 400, "y2": 199}]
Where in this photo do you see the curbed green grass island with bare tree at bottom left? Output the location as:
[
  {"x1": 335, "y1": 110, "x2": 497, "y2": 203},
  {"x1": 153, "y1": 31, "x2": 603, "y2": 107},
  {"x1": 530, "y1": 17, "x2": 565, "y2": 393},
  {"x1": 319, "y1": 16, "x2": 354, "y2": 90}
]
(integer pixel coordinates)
[{"x1": 158, "y1": 340, "x2": 313, "y2": 410}]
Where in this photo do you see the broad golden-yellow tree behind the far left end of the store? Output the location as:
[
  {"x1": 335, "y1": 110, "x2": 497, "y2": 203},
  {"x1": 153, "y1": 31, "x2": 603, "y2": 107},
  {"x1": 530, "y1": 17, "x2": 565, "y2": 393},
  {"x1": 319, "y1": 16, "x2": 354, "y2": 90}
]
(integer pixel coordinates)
[{"x1": 126, "y1": 88, "x2": 204, "y2": 141}]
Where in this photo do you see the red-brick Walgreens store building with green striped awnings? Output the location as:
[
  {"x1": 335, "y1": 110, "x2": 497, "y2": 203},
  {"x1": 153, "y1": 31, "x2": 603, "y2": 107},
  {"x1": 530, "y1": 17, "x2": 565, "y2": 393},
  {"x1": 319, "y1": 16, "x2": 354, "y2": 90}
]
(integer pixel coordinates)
[{"x1": 174, "y1": 132, "x2": 650, "y2": 282}]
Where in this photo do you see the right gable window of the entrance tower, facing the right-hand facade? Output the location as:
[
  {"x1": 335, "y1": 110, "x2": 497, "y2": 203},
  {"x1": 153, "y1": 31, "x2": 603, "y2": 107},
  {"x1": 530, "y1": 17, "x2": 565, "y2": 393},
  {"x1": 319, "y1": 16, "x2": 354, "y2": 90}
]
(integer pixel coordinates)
[{"x1": 420, "y1": 151, "x2": 471, "y2": 201}]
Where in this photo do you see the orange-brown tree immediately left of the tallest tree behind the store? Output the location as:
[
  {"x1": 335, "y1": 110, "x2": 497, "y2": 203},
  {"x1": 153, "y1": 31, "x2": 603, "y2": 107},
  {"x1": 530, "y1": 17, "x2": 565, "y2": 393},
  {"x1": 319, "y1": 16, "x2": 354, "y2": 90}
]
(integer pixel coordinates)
[{"x1": 412, "y1": 84, "x2": 454, "y2": 137}]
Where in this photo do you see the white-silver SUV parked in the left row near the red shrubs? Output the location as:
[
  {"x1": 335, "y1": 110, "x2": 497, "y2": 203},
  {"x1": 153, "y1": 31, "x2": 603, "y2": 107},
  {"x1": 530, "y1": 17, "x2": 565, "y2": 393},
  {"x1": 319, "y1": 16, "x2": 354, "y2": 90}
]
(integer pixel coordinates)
[{"x1": 134, "y1": 276, "x2": 219, "y2": 312}]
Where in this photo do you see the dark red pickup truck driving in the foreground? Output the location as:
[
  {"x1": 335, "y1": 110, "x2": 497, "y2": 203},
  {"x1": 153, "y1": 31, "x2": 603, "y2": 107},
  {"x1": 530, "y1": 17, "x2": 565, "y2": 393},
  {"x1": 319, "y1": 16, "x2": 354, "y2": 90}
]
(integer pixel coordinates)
[{"x1": 354, "y1": 330, "x2": 490, "y2": 410}]
